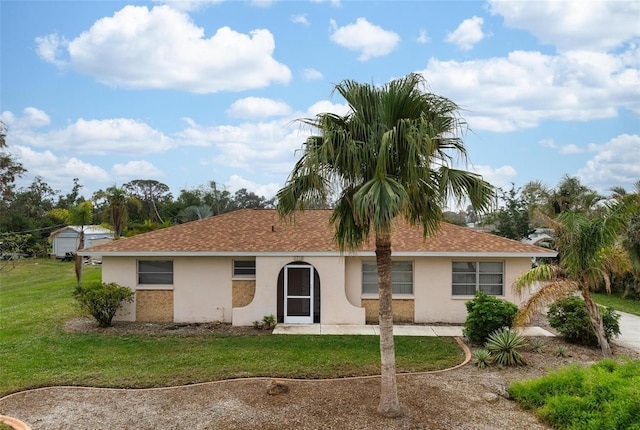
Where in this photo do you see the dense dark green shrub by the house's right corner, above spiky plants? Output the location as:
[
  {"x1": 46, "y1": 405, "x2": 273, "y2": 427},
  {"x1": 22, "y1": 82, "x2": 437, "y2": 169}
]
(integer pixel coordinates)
[{"x1": 462, "y1": 291, "x2": 518, "y2": 344}]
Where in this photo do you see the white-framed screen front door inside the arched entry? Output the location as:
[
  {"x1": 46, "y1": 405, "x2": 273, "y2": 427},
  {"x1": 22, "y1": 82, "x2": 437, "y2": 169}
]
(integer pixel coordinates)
[{"x1": 284, "y1": 264, "x2": 314, "y2": 324}]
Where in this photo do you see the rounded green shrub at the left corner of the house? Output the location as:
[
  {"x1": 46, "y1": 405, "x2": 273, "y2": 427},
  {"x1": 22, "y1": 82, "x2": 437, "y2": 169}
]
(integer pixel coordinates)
[{"x1": 73, "y1": 282, "x2": 135, "y2": 327}]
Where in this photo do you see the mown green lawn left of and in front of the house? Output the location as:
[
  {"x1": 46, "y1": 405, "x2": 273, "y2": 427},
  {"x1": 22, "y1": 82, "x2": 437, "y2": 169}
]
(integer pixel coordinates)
[{"x1": 0, "y1": 260, "x2": 464, "y2": 396}]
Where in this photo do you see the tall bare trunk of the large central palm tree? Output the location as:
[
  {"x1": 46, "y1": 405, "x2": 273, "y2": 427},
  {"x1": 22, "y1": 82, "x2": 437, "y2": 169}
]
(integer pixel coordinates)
[{"x1": 376, "y1": 232, "x2": 400, "y2": 417}]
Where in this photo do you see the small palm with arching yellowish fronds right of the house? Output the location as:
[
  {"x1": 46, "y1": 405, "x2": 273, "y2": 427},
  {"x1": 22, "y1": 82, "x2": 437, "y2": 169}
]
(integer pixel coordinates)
[{"x1": 514, "y1": 209, "x2": 629, "y2": 358}]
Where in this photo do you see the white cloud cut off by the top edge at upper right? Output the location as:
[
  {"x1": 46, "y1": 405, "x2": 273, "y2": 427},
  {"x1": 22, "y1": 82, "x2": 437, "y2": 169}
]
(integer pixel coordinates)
[{"x1": 489, "y1": 0, "x2": 640, "y2": 50}]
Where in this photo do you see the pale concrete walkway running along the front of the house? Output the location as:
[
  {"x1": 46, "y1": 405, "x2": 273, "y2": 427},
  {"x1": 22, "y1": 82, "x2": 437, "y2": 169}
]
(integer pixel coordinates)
[{"x1": 273, "y1": 324, "x2": 553, "y2": 337}]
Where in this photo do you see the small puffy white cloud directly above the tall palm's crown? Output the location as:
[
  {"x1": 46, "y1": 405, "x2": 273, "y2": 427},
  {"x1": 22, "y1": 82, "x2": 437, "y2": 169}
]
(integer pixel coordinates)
[{"x1": 331, "y1": 18, "x2": 400, "y2": 61}]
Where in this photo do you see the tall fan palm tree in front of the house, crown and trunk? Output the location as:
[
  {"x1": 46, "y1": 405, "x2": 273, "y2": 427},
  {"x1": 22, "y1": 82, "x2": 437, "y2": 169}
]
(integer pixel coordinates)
[{"x1": 277, "y1": 74, "x2": 493, "y2": 416}]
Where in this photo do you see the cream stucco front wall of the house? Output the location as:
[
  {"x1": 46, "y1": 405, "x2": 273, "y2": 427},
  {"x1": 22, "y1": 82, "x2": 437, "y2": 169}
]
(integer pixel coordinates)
[{"x1": 102, "y1": 256, "x2": 531, "y2": 326}]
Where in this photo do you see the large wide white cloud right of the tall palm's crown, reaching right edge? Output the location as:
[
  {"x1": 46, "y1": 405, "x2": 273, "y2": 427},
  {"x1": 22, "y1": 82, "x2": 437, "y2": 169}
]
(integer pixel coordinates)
[{"x1": 420, "y1": 51, "x2": 640, "y2": 132}]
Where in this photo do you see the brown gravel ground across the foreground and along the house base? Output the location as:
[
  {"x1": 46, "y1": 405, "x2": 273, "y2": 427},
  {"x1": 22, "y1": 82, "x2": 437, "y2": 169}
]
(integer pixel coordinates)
[{"x1": 0, "y1": 322, "x2": 640, "y2": 430}]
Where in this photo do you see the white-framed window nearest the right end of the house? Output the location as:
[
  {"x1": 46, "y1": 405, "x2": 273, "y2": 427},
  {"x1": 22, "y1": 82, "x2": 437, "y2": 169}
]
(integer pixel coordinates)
[{"x1": 452, "y1": 261, "x2": 504, "y2": 296}]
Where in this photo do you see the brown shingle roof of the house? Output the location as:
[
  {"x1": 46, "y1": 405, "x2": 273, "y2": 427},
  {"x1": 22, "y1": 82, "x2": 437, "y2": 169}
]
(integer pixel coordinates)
[{"x1": 85, "y1": 209, "x2": 554, "y2": 256}]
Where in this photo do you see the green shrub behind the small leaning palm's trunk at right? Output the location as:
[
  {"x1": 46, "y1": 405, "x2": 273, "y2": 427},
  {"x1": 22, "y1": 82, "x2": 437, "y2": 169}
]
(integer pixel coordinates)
[{"x1": 547, "y1": 296, "x2": 620, "y2": 346}]
